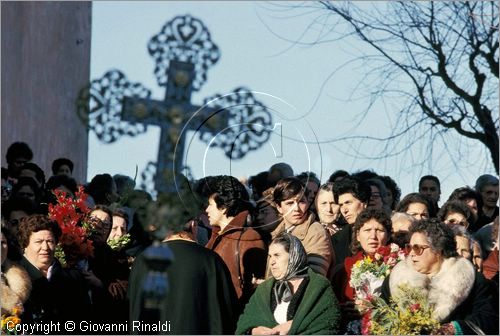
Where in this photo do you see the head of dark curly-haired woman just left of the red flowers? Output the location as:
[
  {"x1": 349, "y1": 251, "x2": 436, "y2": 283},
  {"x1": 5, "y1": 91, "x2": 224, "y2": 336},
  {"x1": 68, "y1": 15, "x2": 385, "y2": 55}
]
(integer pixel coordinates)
[{"x1": 19, "y1": 215, "x2": 62, "y2": 276}]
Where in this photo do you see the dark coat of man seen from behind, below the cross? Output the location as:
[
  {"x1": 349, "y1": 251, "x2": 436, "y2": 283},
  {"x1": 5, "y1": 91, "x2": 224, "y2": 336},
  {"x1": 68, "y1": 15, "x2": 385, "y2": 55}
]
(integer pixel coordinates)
[{"x1": 128, "y1": 221, "x2": 238, "y2": 335}]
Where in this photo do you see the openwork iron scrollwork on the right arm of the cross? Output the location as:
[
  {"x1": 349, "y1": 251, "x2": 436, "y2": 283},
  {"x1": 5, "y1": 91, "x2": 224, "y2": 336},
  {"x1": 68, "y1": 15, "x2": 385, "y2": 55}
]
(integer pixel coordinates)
[{"x1": 199, "y1": 87, "x2": 272, "y2": 159}]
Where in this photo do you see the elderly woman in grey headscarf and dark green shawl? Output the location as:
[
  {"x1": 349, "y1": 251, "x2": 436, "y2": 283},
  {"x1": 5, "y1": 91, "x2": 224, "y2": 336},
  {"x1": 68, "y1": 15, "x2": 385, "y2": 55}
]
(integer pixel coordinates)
[{"x1": 236, "y1": 233, "x2": 340, "y2": 335}]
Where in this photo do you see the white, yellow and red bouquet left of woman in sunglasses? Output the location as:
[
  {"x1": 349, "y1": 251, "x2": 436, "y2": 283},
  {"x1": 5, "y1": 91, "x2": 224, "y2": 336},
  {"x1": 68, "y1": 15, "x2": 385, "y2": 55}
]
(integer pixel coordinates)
[{"x1": 349, "y1": 244, "x2": 406, "y2": 304}]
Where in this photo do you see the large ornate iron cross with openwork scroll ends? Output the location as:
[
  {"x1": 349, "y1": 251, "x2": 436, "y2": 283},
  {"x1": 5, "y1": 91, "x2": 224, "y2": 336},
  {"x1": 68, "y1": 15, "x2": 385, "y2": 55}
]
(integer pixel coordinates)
[{"x1": 77, "y1": 15, "x2": 272, "y2": 192}]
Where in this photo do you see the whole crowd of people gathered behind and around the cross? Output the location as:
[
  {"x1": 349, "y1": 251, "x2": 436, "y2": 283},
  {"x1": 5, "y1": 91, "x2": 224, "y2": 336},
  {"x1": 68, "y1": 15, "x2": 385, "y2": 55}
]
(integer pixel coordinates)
[{"x1": 1, "y1": 142, "x2": 499, "y2": 335}]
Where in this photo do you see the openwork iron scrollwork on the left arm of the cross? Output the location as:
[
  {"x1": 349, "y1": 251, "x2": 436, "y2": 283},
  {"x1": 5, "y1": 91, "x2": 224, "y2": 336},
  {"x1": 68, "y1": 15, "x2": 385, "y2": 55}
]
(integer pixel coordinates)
[{"x1": 77, "y1": 70, "x2": 151, "y2": 143}]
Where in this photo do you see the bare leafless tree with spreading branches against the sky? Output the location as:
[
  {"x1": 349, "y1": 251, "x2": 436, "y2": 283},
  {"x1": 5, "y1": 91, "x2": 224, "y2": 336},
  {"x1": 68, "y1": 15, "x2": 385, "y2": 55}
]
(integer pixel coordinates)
[{"x1": 302, "y1": 1, "x2": 499, "y2": 173}]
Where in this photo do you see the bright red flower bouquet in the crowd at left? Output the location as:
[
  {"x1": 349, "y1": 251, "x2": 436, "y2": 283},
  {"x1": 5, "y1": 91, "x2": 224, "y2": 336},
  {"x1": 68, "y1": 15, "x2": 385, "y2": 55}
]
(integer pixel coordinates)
[{"x1": 49, "y1": 186, "x2": 94, "y2": 267}]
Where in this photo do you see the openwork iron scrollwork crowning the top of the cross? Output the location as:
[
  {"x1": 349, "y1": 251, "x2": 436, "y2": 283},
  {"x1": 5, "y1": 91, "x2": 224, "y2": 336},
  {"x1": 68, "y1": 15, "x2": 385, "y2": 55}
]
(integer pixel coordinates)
[{"x1": 148, "y1": 15, "x2": 220, "y2": 91}]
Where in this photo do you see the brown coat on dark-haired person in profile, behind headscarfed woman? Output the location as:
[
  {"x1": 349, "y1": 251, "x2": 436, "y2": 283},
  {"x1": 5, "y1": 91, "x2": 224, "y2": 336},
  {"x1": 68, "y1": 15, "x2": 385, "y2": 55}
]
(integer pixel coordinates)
[{"x1": 206, "y1": 211, "x2": 267, "y2": 305}]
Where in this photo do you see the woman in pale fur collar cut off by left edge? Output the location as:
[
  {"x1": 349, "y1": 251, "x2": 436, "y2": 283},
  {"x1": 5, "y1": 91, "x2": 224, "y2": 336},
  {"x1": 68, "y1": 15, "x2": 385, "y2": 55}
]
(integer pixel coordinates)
[{"x1": 1, "y1": 223, "x2": 31, "y2": 316}]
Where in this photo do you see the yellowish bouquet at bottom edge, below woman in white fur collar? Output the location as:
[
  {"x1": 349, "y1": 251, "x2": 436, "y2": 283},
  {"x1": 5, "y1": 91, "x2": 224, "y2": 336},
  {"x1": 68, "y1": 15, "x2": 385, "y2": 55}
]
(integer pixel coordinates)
[{"x1": 361, "y1": 284, "x2": 454, "y2": 335}]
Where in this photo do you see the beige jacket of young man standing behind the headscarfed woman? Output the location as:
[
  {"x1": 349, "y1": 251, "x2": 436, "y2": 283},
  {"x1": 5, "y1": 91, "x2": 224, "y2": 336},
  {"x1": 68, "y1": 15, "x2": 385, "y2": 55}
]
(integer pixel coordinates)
[{"x1": 266, "y1": 213, "x2": 335, "y2": 279}]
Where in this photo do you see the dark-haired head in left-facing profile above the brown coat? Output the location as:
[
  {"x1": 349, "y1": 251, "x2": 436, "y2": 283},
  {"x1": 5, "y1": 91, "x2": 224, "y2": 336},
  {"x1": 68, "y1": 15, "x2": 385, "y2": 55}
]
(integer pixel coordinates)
[{"x1": 206, "y1": 175, "x2": 252, "y2": 230}]
